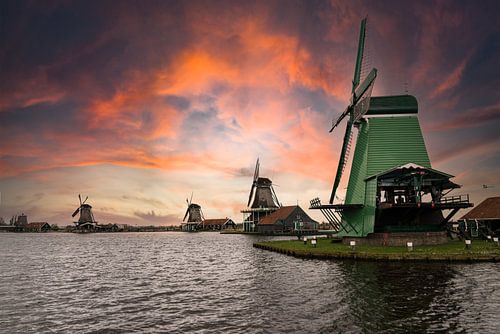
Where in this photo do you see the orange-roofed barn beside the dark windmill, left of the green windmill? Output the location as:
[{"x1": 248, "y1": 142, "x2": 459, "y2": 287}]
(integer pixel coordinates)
[{"x1": 256, "y1": 205, "x2": 319, "y2": 234}]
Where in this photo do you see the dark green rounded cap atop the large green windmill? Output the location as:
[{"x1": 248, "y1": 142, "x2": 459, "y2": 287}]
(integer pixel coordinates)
[{"x1": 366, "y1": 95, "x2": 418, "y2": 116}]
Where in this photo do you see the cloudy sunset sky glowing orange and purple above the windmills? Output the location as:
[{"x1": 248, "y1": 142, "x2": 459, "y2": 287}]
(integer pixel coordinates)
[{"x1": 0, "y1": 0, "x2": 500, "y2": 226}]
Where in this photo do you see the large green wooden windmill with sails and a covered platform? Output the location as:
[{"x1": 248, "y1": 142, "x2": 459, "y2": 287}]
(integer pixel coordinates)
[{"x1": 311, "y1": 18, "x2": 472, "y2": 237}]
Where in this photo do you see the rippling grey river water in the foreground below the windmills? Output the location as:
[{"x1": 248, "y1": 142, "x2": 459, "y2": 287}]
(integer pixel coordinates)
[{"x1": 0, "y1": 232, "x2": 500, "y2": 333}]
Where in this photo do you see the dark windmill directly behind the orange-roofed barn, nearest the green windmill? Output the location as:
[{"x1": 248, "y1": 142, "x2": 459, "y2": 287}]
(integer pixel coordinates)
[{"x1": 241, "y1": 159, "x2": 281, "y2": 232}]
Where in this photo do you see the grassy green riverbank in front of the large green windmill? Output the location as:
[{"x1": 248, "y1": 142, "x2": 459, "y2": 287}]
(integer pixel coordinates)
[{"x1": 253, "y1": 238, "x2": 500, "y2": 262}]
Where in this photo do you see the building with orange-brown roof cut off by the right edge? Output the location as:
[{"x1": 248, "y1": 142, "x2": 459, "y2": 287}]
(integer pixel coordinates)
[{"x1": 460, "y1": 196, "x2": 500, "y2": 235}]
